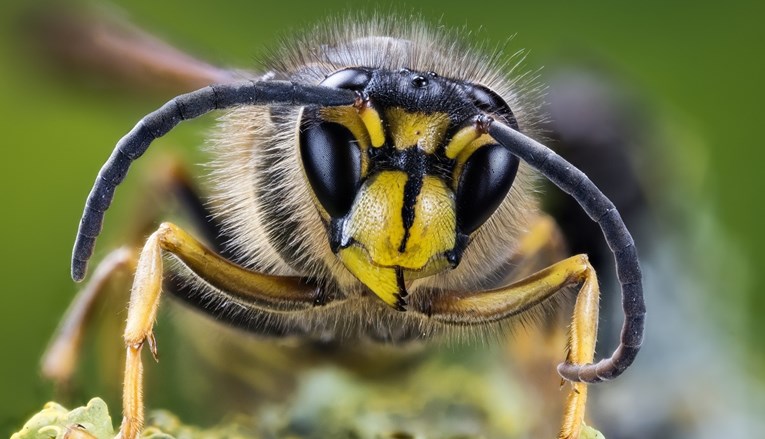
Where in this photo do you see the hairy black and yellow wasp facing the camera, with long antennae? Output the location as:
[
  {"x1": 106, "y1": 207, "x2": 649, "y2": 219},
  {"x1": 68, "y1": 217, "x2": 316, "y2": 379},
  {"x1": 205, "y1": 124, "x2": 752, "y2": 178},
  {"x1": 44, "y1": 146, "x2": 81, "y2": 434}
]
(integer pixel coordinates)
[{"x1": 38, "y1": 10, "x2": 645, "y2": 439}]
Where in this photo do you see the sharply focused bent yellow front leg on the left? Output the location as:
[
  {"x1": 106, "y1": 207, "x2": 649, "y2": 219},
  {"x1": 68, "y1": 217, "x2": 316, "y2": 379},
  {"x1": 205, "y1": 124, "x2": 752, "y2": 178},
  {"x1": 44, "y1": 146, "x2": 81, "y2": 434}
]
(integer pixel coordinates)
[{"x1": 119, "y1": 223, "x2": 318, "y2": 439}]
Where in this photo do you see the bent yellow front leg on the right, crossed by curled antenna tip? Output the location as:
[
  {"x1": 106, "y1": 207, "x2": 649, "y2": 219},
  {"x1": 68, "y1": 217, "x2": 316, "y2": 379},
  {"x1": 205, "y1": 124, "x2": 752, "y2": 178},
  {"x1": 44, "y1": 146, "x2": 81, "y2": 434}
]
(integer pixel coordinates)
[{"x1": 428, "y1": 255, "x2": 600, "y2": 439}]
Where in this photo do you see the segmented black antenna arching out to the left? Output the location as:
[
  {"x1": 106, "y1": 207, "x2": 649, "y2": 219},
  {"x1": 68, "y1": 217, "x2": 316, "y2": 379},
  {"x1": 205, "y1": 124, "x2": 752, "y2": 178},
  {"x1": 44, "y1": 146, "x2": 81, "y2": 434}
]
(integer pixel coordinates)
[{"x1": 72, "y1": 81, "x2": 356, "y2": 282}]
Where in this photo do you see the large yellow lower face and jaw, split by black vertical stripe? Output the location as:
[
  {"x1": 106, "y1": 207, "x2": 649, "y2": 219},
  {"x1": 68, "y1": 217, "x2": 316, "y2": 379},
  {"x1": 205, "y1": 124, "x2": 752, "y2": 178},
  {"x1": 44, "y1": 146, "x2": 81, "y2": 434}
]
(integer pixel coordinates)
[{"x1": 338, "y1": 171, "x2": 456, "y2": 306}]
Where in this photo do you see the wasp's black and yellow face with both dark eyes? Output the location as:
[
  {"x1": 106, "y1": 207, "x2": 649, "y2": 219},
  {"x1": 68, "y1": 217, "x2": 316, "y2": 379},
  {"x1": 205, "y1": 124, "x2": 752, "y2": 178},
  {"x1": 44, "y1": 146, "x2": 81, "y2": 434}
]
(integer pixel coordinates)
[{"x1": 299, "y1": 68, "x2": 518, "y2": 309}]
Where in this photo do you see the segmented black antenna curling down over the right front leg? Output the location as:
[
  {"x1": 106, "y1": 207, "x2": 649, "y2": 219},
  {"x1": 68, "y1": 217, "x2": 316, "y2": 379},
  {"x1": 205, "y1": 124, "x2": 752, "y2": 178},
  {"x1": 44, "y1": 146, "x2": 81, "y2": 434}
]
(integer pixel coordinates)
[{"x1": 479, "y1": 116, "x2": 645, "y2": 383}]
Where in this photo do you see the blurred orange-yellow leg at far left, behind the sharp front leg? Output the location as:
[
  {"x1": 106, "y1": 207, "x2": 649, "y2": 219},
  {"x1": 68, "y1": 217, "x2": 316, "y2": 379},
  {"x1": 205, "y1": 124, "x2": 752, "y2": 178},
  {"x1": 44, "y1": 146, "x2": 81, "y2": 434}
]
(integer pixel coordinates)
[{"x1": 41, "y1": 247, "x2": 138, "y2": 387}]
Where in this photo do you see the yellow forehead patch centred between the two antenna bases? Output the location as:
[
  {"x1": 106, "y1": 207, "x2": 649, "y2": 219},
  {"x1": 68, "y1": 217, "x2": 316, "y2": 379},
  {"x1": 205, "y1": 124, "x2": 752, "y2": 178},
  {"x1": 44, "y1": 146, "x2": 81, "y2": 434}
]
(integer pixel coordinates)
[{"x1": 385, "y1": 108, "x2": 449, "y2": 154}]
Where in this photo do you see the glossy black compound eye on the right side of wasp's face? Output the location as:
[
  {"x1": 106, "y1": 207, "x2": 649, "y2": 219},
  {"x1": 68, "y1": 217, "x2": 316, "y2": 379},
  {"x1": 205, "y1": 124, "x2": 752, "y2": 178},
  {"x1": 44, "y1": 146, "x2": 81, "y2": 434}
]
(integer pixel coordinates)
[{"x1": 457, "y1": 144, "x2": 518, "y2": 234}]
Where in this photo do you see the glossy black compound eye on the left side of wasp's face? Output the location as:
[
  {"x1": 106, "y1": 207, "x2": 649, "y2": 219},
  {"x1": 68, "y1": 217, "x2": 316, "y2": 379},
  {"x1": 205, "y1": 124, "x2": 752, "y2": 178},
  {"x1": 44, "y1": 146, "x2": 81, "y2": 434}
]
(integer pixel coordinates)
[{"x1": 300, "y1": 116, "x2": 361, "y2": 218}]
